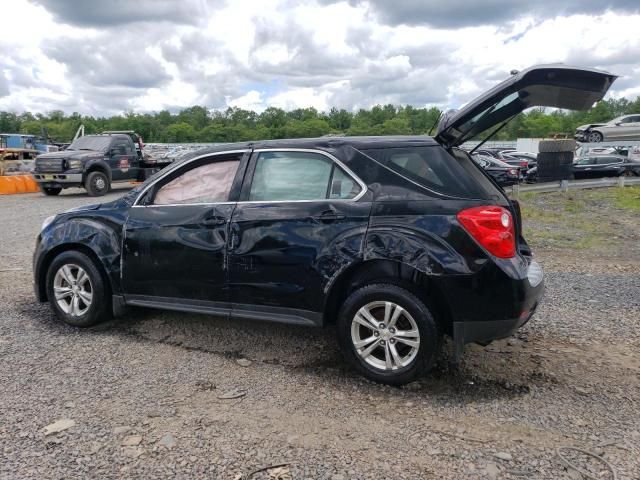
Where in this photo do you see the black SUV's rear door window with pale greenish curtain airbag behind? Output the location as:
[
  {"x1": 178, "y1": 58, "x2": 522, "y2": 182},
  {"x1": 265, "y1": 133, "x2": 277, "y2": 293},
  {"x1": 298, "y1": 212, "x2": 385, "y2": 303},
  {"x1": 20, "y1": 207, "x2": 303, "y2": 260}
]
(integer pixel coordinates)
[{"x1": 249, "y1": 151, "x2": 361, "y2": 202}]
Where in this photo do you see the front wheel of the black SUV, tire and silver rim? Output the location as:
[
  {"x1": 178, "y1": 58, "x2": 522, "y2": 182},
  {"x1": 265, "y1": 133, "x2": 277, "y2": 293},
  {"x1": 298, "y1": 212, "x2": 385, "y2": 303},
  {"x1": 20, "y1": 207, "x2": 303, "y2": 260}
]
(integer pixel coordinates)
[{"x1": 46, "y1": 251, "x2": 111, "y2": 327}]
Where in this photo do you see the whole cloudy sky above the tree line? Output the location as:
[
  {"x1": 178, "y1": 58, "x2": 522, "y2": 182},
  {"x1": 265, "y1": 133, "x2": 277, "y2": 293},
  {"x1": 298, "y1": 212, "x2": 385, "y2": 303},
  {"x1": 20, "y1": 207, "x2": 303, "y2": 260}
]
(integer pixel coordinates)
[{"x1": 0, "y1": 0, "x2": 640, "y2": 116}]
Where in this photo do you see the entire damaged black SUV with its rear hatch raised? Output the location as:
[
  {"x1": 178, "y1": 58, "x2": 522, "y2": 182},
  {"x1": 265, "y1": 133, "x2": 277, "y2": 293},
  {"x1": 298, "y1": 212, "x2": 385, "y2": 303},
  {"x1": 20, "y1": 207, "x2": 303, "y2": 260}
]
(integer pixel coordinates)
[{"x1": 34, "y1": 66, "x2": 615, "y2": 384}]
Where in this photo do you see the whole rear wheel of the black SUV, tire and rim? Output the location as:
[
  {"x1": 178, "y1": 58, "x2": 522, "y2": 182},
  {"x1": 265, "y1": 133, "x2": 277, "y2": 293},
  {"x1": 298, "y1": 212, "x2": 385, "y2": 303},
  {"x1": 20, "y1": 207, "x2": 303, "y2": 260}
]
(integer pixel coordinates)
[{"x1": 337, "y1": 284, "x2": 441, "y2": 385}]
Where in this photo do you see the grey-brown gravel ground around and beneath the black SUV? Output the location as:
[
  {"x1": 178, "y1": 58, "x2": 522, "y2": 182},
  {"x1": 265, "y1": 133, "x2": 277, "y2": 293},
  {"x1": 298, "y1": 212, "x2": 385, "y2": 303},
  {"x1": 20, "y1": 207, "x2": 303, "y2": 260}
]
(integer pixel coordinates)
[{"x1": 0, "y1": 186, "x2": 640, "y2": 480}]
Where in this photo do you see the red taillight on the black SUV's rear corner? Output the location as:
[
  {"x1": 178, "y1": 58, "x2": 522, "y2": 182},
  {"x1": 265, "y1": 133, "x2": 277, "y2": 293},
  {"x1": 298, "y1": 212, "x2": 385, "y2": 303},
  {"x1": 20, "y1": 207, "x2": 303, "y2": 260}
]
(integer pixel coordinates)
[{"x1": 458, "y1": 205, "x2": 516, "y2": 258}]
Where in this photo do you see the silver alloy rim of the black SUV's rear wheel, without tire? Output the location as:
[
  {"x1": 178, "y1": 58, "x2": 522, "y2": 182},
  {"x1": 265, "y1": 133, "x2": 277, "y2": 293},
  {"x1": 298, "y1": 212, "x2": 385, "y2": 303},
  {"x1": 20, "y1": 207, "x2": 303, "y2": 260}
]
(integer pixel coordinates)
[{"x1": 351, "y1": 301, "x2": 420, "y2": 371}]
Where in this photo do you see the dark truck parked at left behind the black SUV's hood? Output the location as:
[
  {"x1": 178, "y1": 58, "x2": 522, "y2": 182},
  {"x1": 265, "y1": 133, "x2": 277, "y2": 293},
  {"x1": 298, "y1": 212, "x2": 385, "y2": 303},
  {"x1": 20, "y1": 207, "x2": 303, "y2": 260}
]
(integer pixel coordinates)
[{"x1": 33, "y1": 132, "x2": 157, "y2": 197}]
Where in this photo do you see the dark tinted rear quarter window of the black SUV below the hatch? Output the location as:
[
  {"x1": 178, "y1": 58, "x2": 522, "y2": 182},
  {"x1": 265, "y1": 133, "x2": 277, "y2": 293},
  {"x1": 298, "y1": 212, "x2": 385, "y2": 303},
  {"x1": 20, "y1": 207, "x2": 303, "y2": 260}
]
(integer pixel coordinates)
[{"x1": 362, "y1": 146, "x2": 501, "y2": 199}]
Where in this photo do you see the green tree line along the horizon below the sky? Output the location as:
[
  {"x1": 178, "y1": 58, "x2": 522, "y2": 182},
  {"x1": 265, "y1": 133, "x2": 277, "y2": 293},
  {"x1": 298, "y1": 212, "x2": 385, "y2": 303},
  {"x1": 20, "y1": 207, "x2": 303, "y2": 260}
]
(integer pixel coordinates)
[{"x1": 0, "y1": 97, "x2": 640, "y2": 143}]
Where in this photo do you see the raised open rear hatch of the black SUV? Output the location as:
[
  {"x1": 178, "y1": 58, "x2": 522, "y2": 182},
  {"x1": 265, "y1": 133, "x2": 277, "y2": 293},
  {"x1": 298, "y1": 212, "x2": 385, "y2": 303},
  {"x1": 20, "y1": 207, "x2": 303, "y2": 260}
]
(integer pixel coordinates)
[{"x1": 434, "y1": 64, "x2": 618, "y2": 148}]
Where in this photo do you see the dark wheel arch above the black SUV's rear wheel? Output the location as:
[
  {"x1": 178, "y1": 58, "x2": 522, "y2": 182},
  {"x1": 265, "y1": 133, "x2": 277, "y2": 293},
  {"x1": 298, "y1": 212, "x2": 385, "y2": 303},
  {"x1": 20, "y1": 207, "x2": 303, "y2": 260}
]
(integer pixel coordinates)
[{"x1": 323, "y1": 259, "x2": 453, "y2": 333}]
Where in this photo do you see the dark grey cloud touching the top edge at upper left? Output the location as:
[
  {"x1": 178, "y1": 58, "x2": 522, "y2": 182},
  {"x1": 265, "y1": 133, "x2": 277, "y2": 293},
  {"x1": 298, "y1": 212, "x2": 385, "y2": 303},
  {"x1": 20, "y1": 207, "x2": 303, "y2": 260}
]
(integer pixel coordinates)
[{"x1": 32, "y1": 0, "x2": 209, "y2": 28}]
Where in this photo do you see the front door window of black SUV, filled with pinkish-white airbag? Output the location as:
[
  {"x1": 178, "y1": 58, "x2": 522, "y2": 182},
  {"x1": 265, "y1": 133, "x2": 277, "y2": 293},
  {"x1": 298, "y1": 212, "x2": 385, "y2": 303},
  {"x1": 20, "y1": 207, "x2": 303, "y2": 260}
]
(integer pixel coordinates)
[{"x1": 153, "y1": 160, "x2": 240, "y2": 205}]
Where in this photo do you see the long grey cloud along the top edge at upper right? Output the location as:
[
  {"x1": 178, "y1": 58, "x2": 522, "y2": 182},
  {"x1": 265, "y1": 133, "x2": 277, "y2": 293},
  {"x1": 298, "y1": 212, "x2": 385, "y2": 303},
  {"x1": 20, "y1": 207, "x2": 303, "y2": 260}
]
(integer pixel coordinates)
[{"x1": 336, "y1": 0, "x2": 640, "y2": 28}]
